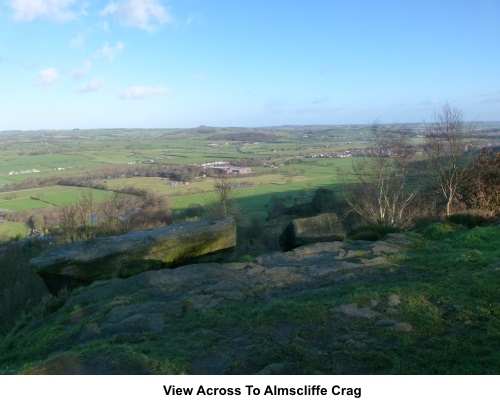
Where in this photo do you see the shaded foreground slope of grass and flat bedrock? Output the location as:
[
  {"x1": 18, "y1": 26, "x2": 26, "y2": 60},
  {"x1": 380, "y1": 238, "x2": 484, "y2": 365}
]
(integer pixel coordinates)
[{"x1": 0, "y1": 225, "x2": 500, "y2": 374}]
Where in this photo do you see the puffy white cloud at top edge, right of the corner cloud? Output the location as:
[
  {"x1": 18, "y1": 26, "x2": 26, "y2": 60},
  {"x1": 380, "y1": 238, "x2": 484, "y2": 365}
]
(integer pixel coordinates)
[{"x1": 101, "y1": 0, "x2": 173, "y2": 32}]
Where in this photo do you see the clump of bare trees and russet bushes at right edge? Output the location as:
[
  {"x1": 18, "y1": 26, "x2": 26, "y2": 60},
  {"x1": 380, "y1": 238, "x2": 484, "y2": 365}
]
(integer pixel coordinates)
[{"x1": 344, "y1": 103, "x2": 500, "y2": 228}]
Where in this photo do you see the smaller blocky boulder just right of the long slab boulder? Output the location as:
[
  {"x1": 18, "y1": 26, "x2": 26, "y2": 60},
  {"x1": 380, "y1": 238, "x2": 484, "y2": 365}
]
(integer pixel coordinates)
[{"x1": 280, "y1": 213, "x2": 345, "y2": 250}]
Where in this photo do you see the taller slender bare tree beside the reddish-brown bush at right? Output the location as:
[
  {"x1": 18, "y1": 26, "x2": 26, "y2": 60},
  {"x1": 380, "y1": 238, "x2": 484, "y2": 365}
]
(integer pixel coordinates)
[{"x1": 425, "y1": 103, "x2": 476, "y2": 216}]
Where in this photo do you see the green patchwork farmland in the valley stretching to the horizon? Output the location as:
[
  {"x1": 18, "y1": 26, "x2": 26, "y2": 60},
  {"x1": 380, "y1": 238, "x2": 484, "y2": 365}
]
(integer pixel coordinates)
[{"x1": 0, "y1": 123, "x2": 500, "y2": 236}]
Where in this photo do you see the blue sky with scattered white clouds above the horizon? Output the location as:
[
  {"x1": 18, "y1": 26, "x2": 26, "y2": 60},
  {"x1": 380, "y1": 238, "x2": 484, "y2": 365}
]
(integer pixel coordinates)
[{"x1": 0, "y1": 0, "x2": 500, "y2": 130}]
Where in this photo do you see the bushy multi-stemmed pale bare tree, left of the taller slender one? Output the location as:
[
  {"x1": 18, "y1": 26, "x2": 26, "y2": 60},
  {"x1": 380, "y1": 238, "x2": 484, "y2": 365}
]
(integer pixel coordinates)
[{"x1": 346, "y1": 122, "x2": 419, "y2": 227}]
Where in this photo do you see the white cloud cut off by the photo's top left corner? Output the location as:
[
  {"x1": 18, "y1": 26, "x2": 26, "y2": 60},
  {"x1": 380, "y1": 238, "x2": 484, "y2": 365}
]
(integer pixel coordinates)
[{"x1": 7, "y1": 0, "x2": 76, "y2": 21}]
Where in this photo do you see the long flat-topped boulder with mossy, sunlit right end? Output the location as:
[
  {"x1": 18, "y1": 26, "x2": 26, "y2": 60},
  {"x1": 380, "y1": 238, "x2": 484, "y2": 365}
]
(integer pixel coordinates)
[{"x1": 30, "y1": 217, "x2": 236, "y2": 291}]
